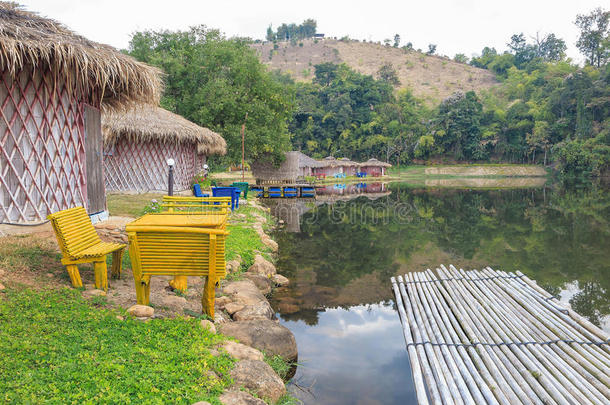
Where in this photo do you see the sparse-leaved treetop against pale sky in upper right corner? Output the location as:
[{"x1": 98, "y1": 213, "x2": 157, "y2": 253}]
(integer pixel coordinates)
[{"x1": 574, "y1": 7, "x2": 610, "y2": 68}]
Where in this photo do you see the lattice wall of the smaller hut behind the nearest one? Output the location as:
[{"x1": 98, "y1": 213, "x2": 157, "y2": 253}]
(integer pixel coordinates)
[{"x1": 104, "y1": 137, "x2": 201, "y2": 192}]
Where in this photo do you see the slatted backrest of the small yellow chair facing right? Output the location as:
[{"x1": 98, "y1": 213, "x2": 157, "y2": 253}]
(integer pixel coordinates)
[{"x1": 48, "y1": 207, "x2": 101, "y2": 257}]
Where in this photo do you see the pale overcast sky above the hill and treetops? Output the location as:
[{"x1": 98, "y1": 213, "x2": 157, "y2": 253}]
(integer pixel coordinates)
[{"x1": 17, "y1": 0, "x2": 607, "y2": 62}]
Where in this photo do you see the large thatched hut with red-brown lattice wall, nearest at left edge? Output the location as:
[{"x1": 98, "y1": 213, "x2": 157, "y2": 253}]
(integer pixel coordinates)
[{"x1": 0, "y1": 2, "x2": 162, "y2": 223}]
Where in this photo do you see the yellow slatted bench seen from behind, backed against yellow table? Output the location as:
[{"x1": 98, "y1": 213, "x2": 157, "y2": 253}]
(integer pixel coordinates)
[{"x1": 126, "y1": 221, "x2": 228, "y2": 318}]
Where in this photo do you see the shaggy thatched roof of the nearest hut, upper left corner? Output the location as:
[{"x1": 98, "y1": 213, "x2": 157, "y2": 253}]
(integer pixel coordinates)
[{"x1": 0, "y1": 2, "x2": 163, "y2": 104}]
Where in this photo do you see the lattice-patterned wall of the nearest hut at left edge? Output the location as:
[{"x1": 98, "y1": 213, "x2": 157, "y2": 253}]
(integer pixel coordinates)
[{"x1": 0, "y1": 67, "x2": 89, "y2": 223}]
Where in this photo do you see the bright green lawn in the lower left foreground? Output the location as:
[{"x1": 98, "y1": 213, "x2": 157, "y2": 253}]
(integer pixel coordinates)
[{"x1": 0, "y1": 289, "x2": 233, "y2": 404}]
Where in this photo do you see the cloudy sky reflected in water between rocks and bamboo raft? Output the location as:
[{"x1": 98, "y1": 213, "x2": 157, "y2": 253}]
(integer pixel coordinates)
[{"x1": 284, "y1": 303, "x2": 415, "y2": 405}]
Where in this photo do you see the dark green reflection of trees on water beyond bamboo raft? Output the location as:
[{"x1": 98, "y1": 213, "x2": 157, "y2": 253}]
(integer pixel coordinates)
[{"x1": 276, "y1": 185, "x2": 610, "y2": 321}]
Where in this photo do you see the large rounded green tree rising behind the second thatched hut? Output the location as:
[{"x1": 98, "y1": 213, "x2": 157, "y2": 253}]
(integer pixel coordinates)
[{"x1": 129, "y1": 26, "x2": 294, "y2": 162}]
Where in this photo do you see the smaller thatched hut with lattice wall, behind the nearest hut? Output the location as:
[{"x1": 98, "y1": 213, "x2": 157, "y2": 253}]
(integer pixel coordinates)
[{"x1": 102, "y1": 105, "x2": 227, "y2": 192}]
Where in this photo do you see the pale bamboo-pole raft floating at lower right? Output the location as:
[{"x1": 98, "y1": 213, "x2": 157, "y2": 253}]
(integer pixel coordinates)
[{"x1": 391, "y1": 265, "x2": 610, "y2": 404}]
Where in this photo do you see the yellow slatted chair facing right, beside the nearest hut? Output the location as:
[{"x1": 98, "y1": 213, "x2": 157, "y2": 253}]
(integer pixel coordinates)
[{"x1": 48, "y1": 207, "x2": 126, "y2": 290}]
